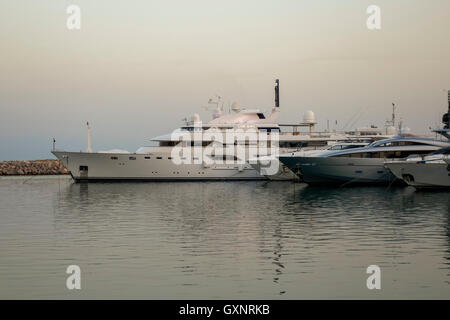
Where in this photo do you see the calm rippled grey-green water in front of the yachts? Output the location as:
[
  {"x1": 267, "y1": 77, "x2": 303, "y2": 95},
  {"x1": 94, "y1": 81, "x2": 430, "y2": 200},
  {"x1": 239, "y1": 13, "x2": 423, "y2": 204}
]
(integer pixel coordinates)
[{"x1": 0, "y1": 177, "x2": 450, "y2": 299}]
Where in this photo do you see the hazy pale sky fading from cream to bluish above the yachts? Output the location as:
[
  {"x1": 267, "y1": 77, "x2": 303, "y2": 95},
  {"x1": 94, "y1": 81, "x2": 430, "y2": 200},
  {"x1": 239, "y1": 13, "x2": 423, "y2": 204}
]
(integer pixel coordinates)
[{"x1": 0, "y1": 0, "x2": 450, "y2": 160}]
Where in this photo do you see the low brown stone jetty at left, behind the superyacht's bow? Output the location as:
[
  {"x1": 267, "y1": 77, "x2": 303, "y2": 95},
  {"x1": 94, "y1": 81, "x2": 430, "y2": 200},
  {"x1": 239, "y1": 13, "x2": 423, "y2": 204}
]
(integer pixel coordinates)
[{"x1": 0, "y1": 159, "x2": 69, "y2": 176}]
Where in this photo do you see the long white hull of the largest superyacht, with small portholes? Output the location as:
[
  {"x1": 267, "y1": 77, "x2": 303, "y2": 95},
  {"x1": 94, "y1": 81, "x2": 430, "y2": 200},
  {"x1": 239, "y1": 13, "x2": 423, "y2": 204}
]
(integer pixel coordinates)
[{"x1": 52, "y1": 151, "x2": 267, "y2": 182}]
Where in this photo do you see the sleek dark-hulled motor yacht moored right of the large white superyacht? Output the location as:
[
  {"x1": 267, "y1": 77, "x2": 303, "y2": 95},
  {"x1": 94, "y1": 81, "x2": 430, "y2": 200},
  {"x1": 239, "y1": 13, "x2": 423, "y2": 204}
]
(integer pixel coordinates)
[{"x1": 279, "y1": 136, "x2": 450, "y2": 185}]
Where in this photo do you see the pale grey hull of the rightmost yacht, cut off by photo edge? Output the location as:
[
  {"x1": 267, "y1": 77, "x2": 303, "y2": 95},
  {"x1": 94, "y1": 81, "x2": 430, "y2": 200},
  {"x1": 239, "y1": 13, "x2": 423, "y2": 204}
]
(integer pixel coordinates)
[{"x1": 385, "y1": 161, "x2": 450, "y2": 188}]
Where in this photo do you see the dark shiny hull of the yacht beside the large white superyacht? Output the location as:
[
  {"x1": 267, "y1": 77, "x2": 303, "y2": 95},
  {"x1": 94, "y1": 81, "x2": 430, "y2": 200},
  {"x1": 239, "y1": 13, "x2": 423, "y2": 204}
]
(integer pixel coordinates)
[{"x1": 280, "y1": 157, "x2": 395, "y2": 185}]
